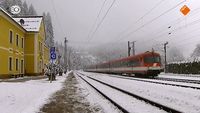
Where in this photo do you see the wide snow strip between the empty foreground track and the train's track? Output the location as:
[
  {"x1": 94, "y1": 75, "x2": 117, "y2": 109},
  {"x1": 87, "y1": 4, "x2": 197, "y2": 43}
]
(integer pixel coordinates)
[{"x1": 81, "y1": 73, "x2": 200, "y2": 113}]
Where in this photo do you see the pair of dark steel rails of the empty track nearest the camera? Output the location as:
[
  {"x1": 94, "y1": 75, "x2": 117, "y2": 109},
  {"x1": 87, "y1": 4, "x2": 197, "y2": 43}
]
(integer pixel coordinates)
[{"x1": 77, "y1": 73, "x2": 181, "y2": 113}]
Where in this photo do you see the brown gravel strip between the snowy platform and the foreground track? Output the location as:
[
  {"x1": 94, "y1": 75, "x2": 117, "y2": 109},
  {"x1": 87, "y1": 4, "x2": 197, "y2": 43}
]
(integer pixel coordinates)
[{"x1": 39, "y1": 74, "x2": 103, "y2": 113}]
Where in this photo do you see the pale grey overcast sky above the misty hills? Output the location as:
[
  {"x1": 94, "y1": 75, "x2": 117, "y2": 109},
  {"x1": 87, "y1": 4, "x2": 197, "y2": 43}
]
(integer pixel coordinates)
[{"x1": 26, "y1": 0, "x2": 200, "y2": 56}]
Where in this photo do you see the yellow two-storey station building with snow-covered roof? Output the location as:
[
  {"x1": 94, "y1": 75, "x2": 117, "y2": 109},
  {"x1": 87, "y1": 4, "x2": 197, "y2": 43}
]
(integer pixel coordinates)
[{"x1": 0, "y1": 8, "x2": 49, "y2": 78}]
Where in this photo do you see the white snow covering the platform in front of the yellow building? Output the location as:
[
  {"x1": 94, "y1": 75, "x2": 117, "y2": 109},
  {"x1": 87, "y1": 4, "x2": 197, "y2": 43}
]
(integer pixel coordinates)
[{"x1": 0, "y1": 74, "x2": 67, "y2": 113}]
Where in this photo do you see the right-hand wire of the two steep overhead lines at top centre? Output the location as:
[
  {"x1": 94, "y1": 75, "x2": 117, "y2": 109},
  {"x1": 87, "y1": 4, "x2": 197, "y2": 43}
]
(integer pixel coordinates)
[{"x1": 88, "y1": 0, "x2": 116, "y2": 42}]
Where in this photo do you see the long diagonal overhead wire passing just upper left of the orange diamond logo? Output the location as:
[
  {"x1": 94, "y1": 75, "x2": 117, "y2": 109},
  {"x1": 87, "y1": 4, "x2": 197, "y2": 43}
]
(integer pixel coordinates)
[{"x1": 117, "y1": 0, "x2": 186, "y2": 41}]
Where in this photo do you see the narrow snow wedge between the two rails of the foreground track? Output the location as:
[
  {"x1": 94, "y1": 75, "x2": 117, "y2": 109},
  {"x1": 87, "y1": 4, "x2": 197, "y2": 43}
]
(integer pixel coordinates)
[{"x1": 78, "y1": 74, "x2": 165, "y2": 113}]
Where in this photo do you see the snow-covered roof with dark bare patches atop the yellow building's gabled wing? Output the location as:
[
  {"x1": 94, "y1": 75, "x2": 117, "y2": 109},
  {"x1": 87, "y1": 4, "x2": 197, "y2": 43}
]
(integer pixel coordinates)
[{"x1": 13, "y1": 16, "x2": 42, "y2": 32}]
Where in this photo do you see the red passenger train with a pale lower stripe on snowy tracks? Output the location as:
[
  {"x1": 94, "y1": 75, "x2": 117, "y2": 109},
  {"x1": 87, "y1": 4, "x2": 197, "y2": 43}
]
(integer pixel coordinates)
[{"x1": 84, "y1": 51, "x2": 164, "y2": 77}]
